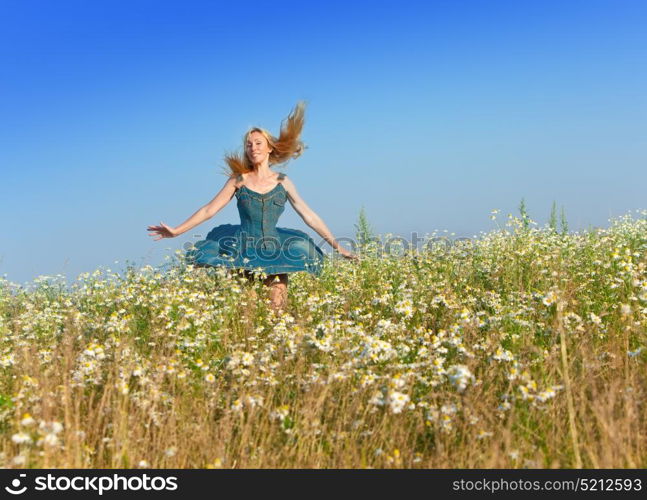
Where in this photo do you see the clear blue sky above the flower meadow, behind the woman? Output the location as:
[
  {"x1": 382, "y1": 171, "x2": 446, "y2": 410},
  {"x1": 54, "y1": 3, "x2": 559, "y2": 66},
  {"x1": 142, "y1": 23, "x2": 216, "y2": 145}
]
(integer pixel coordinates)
[{"x1": 0, "y1": 0, "x2": 647, "y2": 283}]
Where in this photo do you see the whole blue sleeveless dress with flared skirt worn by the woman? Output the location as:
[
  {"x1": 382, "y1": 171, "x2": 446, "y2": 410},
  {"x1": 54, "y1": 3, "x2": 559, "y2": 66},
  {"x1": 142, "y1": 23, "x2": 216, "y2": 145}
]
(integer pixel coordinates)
[{"x1": 186, "y1": 173, "x2": 324, "y2": 275}]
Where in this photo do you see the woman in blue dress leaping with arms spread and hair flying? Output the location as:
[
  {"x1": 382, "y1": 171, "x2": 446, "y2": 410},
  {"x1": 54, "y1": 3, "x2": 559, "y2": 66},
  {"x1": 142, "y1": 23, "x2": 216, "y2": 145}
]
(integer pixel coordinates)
[{"x1": 148, "y1": 103, "x2": 358, "y2": 312}]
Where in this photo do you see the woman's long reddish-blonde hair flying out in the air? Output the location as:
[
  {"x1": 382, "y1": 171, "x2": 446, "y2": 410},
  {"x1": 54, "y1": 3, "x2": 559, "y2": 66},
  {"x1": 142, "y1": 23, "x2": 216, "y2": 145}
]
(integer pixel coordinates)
[{"x1": 225, "y1": 101, "x2": 306, "y2": 177}]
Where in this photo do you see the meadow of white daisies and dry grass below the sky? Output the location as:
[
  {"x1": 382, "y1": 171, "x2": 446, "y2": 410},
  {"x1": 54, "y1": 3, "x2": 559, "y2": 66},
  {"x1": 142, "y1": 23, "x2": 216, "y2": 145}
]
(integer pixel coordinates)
[{"x1": 0, "y1": 211, "x2": 647, "y2": 468}]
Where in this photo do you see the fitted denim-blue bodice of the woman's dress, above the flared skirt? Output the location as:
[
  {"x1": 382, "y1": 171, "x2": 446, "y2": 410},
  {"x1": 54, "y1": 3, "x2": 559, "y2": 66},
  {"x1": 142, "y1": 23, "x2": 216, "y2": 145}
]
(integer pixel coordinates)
[{"x1": 236, "y1": 173, "x2": 288, "y2": 247}]
